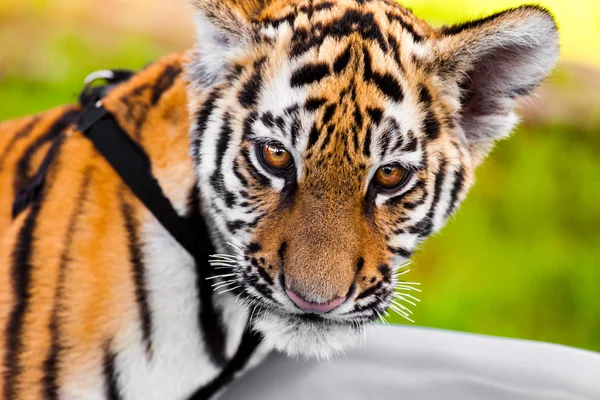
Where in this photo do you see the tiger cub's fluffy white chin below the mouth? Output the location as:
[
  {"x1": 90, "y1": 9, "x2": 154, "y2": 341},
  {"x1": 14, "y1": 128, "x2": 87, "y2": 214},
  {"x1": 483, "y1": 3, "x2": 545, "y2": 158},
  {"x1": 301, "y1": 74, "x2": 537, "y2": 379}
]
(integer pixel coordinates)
[{"x1": 254, "y1": 311, "x2": 364, "y2": 360}]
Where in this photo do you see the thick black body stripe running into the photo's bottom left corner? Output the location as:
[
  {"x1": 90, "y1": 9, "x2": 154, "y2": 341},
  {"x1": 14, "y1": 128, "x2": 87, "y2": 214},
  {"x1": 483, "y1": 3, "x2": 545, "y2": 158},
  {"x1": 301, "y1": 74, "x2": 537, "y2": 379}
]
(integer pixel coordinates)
[{"x1": 4, "y1": 201, "x2": 41, "y2": 399}]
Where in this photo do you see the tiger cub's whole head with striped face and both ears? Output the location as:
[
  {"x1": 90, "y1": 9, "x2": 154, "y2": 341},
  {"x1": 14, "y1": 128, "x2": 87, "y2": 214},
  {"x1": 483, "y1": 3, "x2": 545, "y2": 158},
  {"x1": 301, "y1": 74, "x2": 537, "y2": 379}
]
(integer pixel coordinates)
[{"x1": 188, "y1": 0, "x2": 558, "y2": 357}]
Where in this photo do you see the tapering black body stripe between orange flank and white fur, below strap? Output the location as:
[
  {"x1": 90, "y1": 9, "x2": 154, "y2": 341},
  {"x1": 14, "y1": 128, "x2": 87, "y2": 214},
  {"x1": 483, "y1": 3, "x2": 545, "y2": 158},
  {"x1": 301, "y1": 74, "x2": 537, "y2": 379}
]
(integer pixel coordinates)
[{"x1": 119, "y1": 188, "x2": 152, "y2": 358}]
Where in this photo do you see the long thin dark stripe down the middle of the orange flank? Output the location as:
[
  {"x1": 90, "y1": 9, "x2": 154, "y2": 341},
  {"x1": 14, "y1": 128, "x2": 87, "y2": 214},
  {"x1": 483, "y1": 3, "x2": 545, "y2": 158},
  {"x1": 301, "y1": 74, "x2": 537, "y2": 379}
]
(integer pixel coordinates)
[{"x1": 42, "y1": 169, "x2": 92, "y2": 400}]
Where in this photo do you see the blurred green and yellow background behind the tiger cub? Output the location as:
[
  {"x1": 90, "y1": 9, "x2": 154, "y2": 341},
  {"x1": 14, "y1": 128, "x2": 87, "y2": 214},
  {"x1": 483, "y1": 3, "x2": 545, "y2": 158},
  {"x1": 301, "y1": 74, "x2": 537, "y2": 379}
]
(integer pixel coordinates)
[{"x1": 0, "y1": 0, "x2": 600, "y2": 351}]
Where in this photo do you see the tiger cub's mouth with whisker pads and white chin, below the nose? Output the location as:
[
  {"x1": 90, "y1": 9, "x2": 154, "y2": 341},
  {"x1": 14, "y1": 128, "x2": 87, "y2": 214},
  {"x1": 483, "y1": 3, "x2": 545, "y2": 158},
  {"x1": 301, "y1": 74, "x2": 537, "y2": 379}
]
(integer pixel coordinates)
[{"x1": 211, "y1": 245, "x2": 418, "y2": 359}]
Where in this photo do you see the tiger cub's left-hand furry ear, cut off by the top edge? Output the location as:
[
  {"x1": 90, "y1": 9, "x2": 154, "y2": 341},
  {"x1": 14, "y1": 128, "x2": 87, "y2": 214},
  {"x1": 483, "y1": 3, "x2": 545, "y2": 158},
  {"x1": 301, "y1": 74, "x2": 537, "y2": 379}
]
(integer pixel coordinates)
[{"x1": 189, "y1": 0, "x2": 273, "y2": 87}]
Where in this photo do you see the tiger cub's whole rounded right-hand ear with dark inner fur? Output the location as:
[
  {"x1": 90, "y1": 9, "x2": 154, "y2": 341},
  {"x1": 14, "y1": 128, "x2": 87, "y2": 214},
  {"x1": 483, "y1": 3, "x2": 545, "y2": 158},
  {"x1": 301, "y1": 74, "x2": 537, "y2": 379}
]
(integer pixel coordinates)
[{"x1": 434, "y1": 6, "x2": 559, "y2": 164}]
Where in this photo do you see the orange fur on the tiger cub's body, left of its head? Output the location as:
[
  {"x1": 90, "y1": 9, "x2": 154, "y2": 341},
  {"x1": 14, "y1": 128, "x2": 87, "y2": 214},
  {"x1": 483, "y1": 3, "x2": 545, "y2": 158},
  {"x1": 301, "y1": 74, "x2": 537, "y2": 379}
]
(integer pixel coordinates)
[{"x1": 0, "y1": 56, "x2": 195, "y2": 399}]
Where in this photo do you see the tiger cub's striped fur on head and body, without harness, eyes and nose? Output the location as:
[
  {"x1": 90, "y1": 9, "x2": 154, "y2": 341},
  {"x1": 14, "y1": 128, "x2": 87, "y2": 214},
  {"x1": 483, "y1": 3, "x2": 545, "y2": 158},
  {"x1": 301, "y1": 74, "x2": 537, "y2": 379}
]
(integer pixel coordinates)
[{"x1": 0, "y1": 0, "x2": 557, "y2": 399}]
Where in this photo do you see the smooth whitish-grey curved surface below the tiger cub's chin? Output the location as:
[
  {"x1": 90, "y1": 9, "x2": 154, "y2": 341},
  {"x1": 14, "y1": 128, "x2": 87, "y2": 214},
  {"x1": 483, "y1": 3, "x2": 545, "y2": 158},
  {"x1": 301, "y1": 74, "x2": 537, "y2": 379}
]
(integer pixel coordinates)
[{"x1": 222, "y1": 326, "x2": 600, "y2": 400}]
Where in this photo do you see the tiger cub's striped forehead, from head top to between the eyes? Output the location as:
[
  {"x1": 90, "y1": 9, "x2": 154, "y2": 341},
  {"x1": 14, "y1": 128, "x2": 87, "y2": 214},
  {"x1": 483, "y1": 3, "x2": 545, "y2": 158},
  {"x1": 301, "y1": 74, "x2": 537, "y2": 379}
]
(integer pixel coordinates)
[{"x1": 230, "y1": 0, "x2": 440, "y2": 196}]
